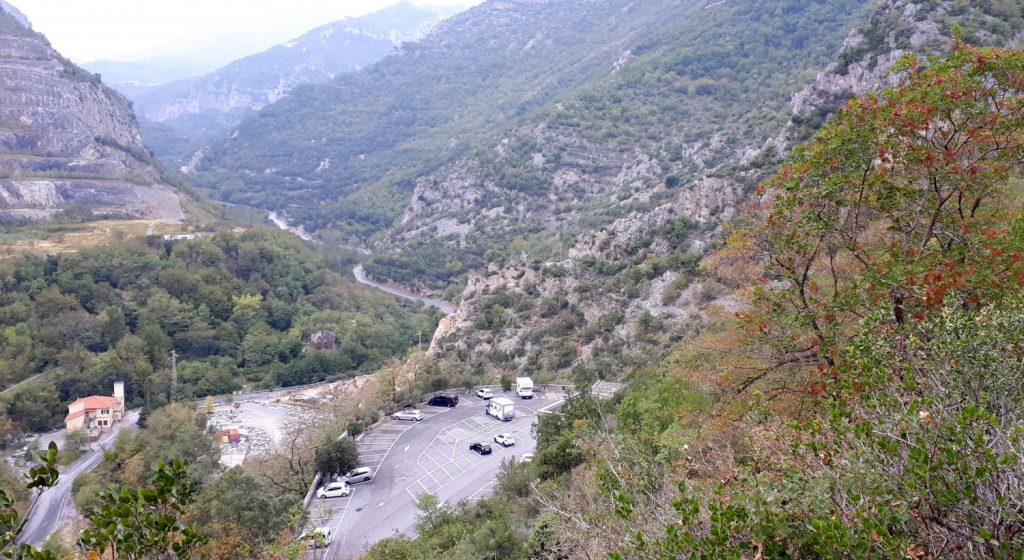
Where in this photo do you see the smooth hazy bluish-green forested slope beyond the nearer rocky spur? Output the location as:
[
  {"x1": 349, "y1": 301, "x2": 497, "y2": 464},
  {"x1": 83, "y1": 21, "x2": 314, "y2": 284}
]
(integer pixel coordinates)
[{"x1": 193, "y1": 0, "x2": 712, "y2": 232}]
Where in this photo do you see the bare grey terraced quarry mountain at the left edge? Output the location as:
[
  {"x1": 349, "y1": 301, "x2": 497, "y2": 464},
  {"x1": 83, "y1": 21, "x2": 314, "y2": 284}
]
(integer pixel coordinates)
[{"x1": 0, "y1": 5, "x2": 182, "y2": 221}]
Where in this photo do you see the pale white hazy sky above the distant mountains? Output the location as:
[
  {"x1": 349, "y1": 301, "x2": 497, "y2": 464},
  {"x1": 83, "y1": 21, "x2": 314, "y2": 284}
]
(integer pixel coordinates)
[{"x1": 18, "y1": 0, "x2": 480, "y2": 62}]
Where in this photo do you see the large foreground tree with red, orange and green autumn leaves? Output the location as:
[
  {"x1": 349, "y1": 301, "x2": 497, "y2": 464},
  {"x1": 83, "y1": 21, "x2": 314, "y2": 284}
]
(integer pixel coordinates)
[{"x1": 737, "y1": 42, "x2": 1024, "y2": 391}]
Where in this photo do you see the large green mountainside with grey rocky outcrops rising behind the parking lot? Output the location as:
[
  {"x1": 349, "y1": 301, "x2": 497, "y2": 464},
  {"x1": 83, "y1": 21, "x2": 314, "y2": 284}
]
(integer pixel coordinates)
[{"x1": 195, "y1": 0, "x2": 1020, "y2": 382}]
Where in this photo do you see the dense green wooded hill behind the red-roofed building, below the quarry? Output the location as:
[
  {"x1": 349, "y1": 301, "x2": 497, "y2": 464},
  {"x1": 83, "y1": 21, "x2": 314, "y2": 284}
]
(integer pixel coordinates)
[{"x1": 0, "y1": 229, "x2": 437, "y2": 431}]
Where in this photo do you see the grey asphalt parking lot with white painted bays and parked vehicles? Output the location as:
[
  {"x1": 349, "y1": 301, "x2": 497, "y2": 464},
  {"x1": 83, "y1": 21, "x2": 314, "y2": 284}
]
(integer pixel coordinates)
[{"x1": 309, "y1": 393, "x2": 560, "y2": 560}]
